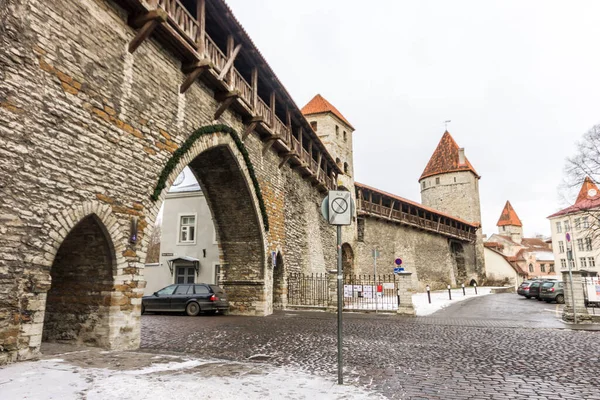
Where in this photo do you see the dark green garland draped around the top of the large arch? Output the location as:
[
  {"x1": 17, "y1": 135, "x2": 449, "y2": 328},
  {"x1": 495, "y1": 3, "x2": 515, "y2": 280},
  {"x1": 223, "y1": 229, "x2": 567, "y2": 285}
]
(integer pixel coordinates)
[{"x1": 150, "y1": 125, "x2": 269, "y2": 231}]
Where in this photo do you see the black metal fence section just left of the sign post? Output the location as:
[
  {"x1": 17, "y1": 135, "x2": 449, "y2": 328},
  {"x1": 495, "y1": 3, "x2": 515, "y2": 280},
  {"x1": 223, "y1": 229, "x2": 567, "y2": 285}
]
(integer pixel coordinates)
[{"x1": 288, "y1": 273, "x2": 329, "y2": 307}]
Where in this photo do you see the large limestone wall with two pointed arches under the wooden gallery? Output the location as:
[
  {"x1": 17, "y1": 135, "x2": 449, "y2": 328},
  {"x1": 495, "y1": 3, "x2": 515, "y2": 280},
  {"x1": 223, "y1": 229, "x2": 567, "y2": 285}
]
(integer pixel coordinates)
[{"x1": 0, "y1": 0, "x2": 335, "y2": 364}]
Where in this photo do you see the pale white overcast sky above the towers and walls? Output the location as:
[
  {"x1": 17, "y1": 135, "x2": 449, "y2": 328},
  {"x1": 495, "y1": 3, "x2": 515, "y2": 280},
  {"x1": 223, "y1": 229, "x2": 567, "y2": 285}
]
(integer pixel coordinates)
[{"x1": 227, "y1": 0, "x2": 600, "y2": 236}]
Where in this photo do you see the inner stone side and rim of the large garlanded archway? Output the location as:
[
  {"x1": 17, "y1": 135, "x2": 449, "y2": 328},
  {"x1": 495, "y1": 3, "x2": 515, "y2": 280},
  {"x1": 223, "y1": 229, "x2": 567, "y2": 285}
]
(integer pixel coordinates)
[{"x1": 153, "y1": 130, "x2": 271, "y2": 315}]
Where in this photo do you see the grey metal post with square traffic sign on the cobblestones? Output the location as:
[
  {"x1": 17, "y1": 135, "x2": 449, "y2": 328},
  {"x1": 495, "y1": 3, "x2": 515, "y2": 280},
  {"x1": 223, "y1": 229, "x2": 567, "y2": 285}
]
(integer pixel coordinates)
[{"x1": 321, "y1": 190, "x2": 354, "y2": 385}]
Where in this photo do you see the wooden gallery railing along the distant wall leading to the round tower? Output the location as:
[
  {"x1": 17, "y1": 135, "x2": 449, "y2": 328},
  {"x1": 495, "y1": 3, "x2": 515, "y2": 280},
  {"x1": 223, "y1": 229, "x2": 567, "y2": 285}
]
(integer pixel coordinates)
[{"x1": 359, "y1": 200, "x2": 477, "y2": 241}]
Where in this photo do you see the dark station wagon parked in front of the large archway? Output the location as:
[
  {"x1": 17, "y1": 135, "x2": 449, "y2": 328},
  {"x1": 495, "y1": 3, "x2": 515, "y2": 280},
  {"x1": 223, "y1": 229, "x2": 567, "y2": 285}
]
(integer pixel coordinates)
[{"x1": 142, "y1": 283, "x2": 229, "y2": 316}]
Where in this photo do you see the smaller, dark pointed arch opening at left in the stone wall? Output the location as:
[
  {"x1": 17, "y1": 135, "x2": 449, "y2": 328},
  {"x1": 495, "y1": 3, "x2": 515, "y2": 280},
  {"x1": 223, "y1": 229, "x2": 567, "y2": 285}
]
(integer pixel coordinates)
[{"x1": 42, "y1": 215, "x2": 115, "y2": 346}]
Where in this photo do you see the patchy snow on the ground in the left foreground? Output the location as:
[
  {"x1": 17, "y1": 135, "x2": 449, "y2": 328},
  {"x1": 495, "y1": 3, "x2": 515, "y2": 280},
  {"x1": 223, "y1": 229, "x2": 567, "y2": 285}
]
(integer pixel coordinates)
[{"x1": 0, "y1": 352, "x2": 381, "y2": 400}]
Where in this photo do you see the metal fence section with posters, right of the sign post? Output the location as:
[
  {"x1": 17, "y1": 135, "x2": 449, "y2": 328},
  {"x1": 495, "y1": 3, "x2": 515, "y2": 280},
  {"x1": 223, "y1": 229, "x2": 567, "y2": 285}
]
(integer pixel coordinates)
[{"x1": 344, "y1": 274, "x2": 399, "y2": 311}]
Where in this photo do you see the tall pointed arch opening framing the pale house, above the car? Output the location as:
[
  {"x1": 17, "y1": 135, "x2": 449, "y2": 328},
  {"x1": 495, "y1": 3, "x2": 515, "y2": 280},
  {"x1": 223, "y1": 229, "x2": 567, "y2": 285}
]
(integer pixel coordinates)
[{"x1": 144, "y1": 141, "x2": 270, "y2": 314}]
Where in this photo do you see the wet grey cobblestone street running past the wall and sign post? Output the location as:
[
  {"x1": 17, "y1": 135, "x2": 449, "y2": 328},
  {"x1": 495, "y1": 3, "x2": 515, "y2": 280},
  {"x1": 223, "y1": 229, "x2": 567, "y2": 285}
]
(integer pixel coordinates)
[{"x1": 142, "y1": 294, "x2": 600, "y2": 399}]
